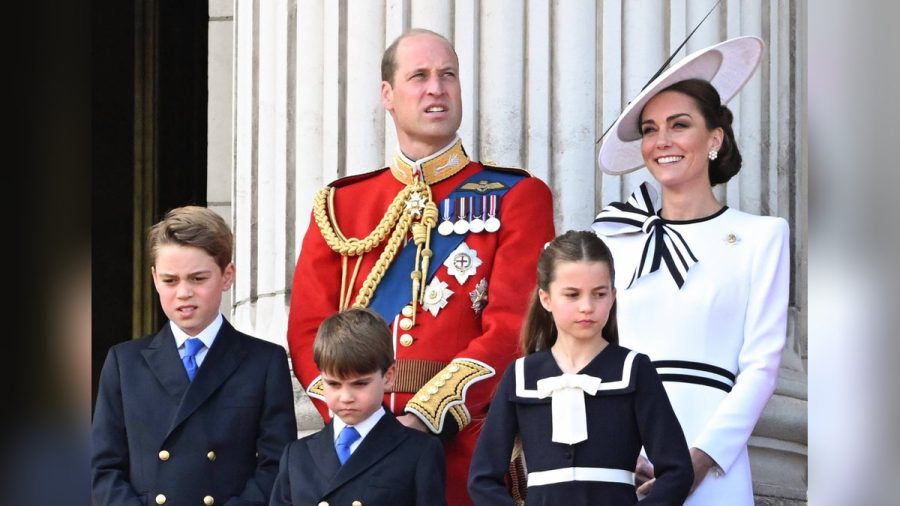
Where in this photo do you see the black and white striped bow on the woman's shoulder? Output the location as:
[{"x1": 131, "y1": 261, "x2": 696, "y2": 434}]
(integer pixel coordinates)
[{"x1": 591, "y1": 183, "x2": 697, "y2": 289}]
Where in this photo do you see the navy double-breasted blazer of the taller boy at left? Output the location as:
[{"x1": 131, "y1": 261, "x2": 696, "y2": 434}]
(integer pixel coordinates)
[{"x1": 91, "y1": 321, "x2": 297, "y2": 506}]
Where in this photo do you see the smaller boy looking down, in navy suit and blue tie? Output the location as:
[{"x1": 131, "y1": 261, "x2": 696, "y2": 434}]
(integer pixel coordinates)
[{"x1": 269, "y1": 308, "x2": 446, "y2": 506}]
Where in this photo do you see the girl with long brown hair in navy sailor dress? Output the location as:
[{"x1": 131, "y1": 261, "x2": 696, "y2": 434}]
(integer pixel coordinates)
[{"x1": 469, "y1": 231, "x2": 693, "y2": 506}]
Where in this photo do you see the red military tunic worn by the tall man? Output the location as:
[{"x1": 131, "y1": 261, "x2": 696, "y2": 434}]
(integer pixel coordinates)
[{"x1": 288, "y1": 162, "x2": 554, "y2": 505}]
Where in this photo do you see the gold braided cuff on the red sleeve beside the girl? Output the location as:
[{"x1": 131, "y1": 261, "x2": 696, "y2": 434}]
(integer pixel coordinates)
[{"x1": 405, "y1": 358, "x2": 495, "y2": 434}]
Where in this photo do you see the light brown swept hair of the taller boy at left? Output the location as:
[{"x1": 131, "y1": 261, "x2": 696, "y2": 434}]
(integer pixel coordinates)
[{"x1": 147, "y1": 206, "x2": 234, "y2": 271}]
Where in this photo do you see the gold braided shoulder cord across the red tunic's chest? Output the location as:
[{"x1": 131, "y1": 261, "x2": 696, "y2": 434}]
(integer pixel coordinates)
[{"x1": 313, "y1": 179, "x2": 439, "y2": 323}]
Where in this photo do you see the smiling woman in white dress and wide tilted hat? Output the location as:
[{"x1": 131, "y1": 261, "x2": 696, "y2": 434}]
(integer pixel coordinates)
[{"x1": 593, "y1": 37, "x2": 790, "y2": 506}]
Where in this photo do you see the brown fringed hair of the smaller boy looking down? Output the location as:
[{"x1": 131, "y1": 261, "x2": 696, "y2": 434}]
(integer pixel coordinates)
[{"x1": 313, "y1": 308, "x2": 394, "y2": 378}]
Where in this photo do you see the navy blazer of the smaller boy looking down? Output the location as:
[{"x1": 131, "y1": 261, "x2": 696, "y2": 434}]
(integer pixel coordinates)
[{"x1": 269, "y1": 412, "x2": 447, "y2": 506}]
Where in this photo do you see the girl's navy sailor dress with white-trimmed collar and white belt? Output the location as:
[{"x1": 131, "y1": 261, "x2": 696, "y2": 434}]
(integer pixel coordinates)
[{"x1": 469, "y1": 345, "x2": 693, "y2": 506}]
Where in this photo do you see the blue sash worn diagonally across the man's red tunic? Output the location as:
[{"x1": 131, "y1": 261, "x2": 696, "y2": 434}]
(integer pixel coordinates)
[{"x1": 369, "y1": 167, "x2": 526, "y2": 324}]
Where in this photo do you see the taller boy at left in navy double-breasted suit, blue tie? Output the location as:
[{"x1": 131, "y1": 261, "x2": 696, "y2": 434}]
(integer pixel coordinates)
[{"x1": 91, "y1": 206, "x2": 297, "y2": 506}]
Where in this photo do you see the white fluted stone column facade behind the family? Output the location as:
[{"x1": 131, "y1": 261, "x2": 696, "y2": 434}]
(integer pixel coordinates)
[{"x1": 207, "y1": 0, "x2": 808, "y2": 504}]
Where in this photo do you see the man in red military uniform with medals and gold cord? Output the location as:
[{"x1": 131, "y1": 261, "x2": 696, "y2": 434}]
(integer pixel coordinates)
[{"x1": 288, "y1": 30, "x2": 554, "y2": 505}]
